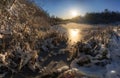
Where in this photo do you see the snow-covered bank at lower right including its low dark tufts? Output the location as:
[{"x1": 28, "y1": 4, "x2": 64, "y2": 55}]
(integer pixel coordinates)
[{"x1": 70, "y1": 27, "x2": 120, "y2": 78}]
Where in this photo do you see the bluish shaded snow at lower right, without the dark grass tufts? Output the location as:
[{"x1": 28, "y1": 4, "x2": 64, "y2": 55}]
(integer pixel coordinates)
[{"x1": 70, "y1": 28, "x2": 120, "y2": 78}]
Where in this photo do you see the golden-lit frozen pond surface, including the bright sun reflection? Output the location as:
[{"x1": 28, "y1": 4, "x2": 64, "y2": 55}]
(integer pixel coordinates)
[{"x1": 59, "y1": 23, "x2": 92, "y2": 44}]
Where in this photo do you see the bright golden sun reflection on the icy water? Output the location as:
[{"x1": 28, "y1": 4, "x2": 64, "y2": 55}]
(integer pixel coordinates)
[{"x1": 68, "y1": 29, "x2": 81, "y2": 44}]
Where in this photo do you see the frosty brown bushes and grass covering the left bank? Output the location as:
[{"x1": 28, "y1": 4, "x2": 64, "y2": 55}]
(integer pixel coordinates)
[{"x1": 0, "y1": 0, "x2": 50, "y2": 76}]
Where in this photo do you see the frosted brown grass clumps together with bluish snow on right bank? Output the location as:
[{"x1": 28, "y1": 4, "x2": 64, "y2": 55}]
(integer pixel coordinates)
[{"x1": 71, "y1": 27, "x2": 120, "y2": 78}]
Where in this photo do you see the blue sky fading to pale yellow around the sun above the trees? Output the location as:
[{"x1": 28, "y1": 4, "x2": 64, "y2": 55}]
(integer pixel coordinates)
[{"x1": 35, "y1": 0, "x2": 120, "y2": 19}]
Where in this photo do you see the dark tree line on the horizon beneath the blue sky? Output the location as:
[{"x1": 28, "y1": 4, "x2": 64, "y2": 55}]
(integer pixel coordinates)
[{"x1": 70, "y1": 9, "x2": 120, "y2": 24}]
